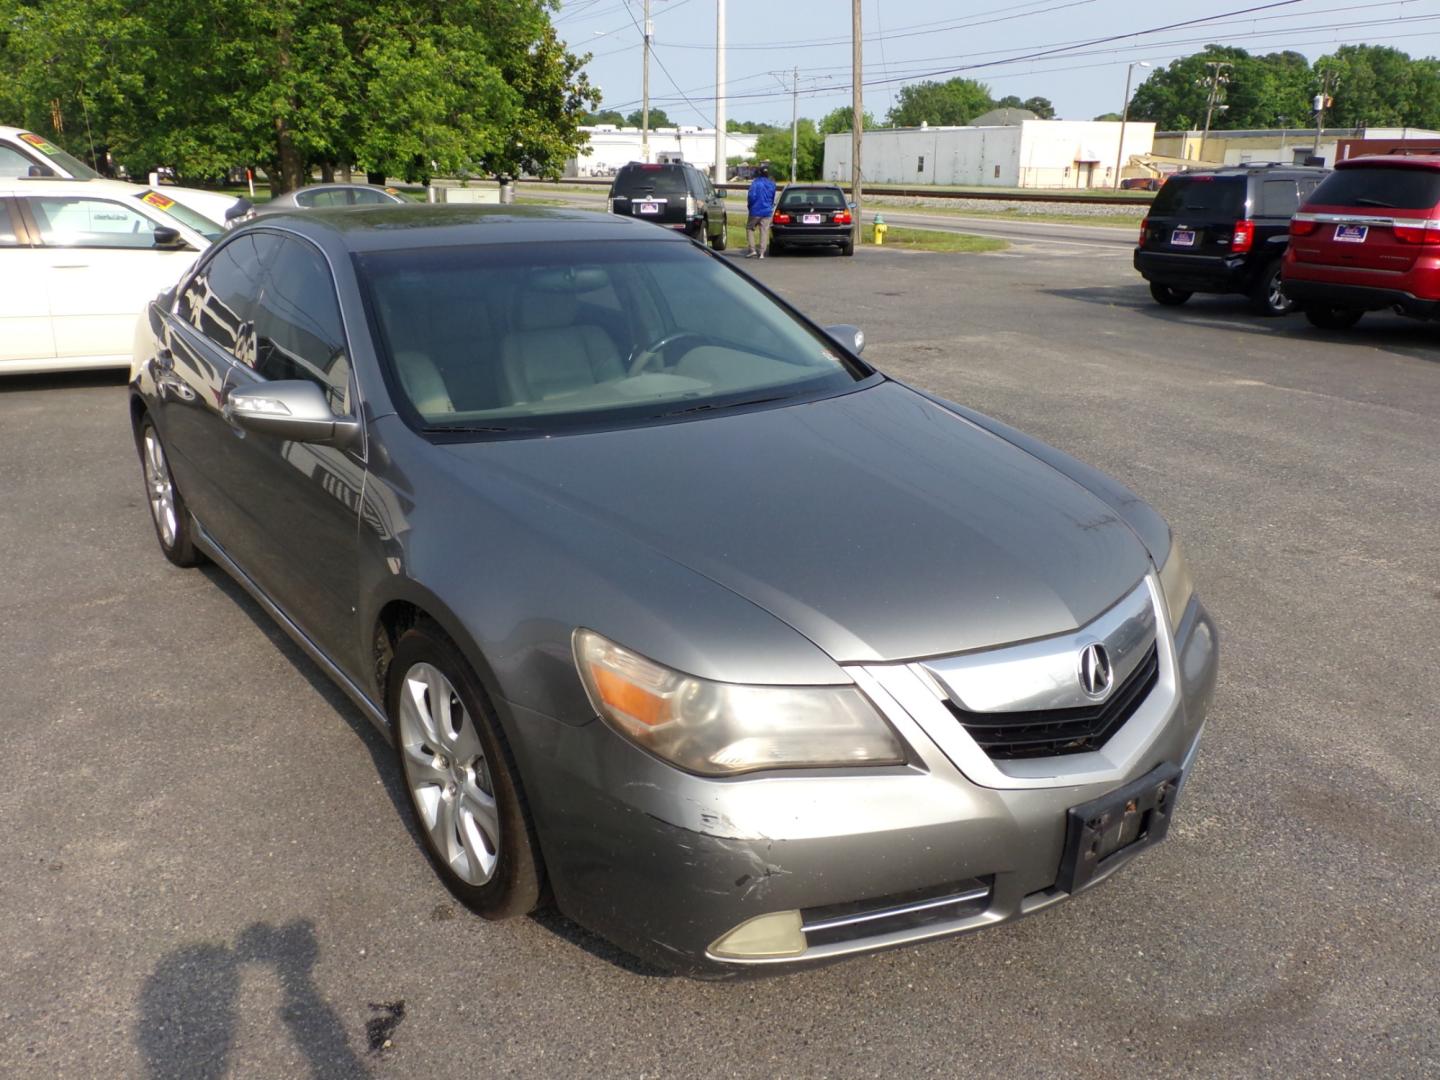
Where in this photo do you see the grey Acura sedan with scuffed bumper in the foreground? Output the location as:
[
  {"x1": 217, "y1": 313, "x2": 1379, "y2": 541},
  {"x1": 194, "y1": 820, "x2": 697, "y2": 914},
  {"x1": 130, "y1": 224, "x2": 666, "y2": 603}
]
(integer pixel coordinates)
[{"x1": 130, "y1": 206, "x2": 1217, "y2": 976}]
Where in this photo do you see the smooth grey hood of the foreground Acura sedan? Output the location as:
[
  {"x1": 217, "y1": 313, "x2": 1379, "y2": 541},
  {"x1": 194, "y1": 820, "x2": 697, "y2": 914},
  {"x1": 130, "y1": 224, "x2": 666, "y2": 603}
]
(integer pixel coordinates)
[{"x1": 445, "y1": 383, "x2": 1151, "y2": 662}]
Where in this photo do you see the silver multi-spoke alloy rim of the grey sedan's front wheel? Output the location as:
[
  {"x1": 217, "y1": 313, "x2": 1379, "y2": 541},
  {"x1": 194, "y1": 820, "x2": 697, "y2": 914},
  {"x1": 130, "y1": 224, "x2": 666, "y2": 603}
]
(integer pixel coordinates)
[{"x1": 399, "y1": 664, "x2": 500, "y2": 886}]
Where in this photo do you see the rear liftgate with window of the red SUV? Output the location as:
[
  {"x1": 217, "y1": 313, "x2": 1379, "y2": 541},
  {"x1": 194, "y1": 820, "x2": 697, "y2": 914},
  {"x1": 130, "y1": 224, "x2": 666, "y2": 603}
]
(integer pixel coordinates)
[{"x1": 1290, "y1": 163, "x2": 1440, "y2": 274}]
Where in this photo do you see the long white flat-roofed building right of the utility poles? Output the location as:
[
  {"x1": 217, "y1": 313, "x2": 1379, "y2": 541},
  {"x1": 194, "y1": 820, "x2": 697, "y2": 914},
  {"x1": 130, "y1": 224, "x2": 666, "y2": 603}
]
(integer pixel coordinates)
[{"x1": 825, "y1": 120, "x2": 1155, "y2": 187}]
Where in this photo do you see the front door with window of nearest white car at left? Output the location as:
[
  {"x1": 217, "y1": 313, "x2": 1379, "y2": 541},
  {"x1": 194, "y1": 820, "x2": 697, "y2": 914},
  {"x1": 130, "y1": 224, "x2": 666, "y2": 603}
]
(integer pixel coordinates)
[{"x1": 20, "y1": 194, "x2": 196, "y2": 364}]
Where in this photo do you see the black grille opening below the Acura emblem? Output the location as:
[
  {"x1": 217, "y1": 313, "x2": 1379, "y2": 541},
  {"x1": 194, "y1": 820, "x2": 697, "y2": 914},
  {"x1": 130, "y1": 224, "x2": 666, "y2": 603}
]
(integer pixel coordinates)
[{"x1": 946, "y1": 645, "x2": 1161, "y2": 760}]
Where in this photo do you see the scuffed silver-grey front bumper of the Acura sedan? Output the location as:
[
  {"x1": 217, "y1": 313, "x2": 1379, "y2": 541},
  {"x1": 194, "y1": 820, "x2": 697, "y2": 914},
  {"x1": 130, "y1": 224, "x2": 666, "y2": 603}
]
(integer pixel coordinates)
[{"x1": 511, "y1": 600, "x2": 1218, "y2": 978}]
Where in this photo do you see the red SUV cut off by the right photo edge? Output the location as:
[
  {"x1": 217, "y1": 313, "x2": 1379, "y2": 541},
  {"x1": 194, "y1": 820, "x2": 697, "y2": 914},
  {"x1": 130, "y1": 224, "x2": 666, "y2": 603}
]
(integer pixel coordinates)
[{"x1": 1283, "y1": 154, "x2": 1440, "y2": 330}]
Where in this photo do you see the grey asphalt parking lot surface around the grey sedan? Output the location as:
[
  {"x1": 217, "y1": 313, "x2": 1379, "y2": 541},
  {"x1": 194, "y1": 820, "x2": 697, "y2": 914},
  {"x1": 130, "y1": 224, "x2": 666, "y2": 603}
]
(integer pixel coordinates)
[{"x1": 0, "y1": 240, "x2": 1440, "y2": 1077}]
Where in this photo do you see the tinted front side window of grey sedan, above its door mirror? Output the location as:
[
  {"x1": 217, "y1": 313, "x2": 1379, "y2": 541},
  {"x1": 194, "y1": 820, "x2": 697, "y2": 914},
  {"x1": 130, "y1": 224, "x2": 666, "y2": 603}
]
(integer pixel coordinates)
[{"x1": 253, "y1": 236, "x2": 350, "y2": 416}]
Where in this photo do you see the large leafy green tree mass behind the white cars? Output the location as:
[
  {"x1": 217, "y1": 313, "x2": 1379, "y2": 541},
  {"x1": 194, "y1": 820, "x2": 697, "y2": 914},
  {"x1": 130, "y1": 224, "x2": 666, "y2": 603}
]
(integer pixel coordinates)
[{"x1": 0, "y1": 0, "x2": 598, "y2": 192}]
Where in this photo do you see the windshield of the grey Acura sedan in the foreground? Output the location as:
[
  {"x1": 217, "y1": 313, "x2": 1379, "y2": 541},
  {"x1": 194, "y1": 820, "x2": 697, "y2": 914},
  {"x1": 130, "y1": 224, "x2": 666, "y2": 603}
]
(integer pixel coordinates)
[{"x1": 365, "y1": 240, "x2": 871, "y2": 433}]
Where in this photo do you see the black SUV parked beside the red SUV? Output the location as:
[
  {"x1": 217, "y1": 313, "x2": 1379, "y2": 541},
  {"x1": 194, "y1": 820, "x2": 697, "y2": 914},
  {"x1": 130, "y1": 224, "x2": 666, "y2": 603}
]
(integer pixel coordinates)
[{"x1": 1135, "y1": 164, "x2": 1329, "y2": 315}]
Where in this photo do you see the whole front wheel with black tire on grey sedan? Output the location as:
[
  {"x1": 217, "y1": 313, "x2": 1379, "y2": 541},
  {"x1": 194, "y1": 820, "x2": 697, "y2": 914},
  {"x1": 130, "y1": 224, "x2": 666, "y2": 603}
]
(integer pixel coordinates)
[{"x1": 386, "y1": 622, "x2": 543, "y2": 919}]
